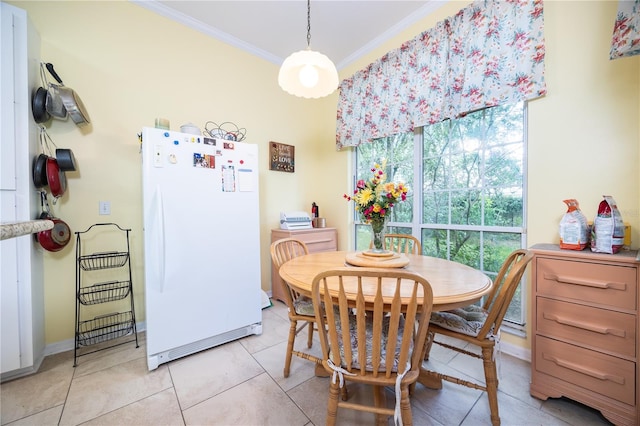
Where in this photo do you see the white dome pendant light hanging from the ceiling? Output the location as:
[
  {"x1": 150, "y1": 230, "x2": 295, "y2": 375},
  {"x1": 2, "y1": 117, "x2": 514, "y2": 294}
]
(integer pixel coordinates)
[{"x1": 278, "y1": 0, "x2": 338, "y2": 98}]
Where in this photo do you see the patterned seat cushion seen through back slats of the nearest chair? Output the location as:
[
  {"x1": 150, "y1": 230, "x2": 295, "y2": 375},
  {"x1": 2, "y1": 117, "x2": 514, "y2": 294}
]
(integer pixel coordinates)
[{"x1": 336, "y1": 315, "x2": 413, "y2": 372}]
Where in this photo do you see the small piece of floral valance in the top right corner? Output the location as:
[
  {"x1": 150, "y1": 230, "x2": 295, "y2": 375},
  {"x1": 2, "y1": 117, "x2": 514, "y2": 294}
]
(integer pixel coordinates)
[{"x1": 609, "y1": 0, "x2": 640, "y2": 59}]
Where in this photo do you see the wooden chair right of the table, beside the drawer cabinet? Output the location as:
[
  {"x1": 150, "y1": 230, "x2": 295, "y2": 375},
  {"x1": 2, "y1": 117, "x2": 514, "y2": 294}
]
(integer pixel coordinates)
[{"x1": 425, "y1": 249, "x2": 533, "y2": 425}]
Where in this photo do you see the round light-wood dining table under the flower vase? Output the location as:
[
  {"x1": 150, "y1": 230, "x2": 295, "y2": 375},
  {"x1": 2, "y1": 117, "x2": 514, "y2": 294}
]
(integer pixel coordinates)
[{"x1": 279, "y1": 251, "x2": 493, "y2": 389}]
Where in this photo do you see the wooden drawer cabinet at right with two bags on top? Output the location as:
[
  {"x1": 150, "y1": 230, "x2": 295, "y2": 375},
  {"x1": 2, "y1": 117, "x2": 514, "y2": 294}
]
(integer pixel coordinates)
[{"x1": 530, "y1": 244, "x2": 640, "y2": 425}]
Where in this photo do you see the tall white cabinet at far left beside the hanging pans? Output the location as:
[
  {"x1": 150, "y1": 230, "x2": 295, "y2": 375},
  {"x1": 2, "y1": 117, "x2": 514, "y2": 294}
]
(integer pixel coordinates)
[{"x1": 0, "y1": 2, "x2": 44, "y2": 380}]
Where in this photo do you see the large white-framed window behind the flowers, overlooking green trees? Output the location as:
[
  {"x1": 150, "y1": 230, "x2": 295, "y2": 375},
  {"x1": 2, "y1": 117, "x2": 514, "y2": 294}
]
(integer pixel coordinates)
[{"x1": 355, "y1": 102, "x2": 526, "y2": 327}]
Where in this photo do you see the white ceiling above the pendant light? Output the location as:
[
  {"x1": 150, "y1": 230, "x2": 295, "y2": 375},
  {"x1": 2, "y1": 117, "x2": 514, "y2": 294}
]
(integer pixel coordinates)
[{"x1": 131, "y1": 0, "x2": 448, "y2": 69}]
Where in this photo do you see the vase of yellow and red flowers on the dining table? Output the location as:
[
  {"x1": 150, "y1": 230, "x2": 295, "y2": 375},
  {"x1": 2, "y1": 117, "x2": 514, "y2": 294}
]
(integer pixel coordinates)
[{"x1": 344, "y1": 161, "x2": 408, "y2": 254}]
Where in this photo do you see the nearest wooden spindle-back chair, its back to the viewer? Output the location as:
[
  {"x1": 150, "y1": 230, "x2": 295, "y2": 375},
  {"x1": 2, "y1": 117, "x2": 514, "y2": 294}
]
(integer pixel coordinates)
[{"x1": 311, "y1": 268, "x2": 433, "y2": 426}]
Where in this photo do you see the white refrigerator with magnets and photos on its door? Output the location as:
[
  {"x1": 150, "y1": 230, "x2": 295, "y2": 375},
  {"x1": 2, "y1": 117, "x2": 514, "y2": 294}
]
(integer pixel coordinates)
[{"x1": 142, "y1": 127, "x2": 262, "y2": 370}]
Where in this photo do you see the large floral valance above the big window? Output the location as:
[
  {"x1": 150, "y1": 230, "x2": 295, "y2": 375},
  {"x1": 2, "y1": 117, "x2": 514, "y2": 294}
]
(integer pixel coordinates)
[{"x1": 336, "y1": 0, "x2": 546, "y2": 149}]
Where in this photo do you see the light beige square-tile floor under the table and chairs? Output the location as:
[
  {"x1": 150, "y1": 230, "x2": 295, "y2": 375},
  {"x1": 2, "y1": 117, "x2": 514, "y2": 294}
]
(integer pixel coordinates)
[{"x1": 0, "y1": 302, "x2": 609, "y2": 426}]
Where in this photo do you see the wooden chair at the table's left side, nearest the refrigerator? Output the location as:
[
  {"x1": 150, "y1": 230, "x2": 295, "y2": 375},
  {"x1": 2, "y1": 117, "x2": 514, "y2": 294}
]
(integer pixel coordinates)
[{"x1": 271, "y1": 238, "x2": 322, "y2": 377}]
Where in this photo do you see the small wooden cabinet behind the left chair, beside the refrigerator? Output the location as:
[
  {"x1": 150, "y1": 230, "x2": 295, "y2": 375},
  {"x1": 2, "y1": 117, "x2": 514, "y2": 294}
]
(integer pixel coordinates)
[{"x1": 271, "y1": 228, "x2": 338, "y2": 302}]
